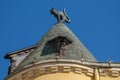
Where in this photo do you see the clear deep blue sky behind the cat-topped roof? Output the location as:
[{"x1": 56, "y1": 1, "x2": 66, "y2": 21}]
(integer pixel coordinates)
[{"x1": 0, "y1": 0, "x2": 120, "y2": 80}]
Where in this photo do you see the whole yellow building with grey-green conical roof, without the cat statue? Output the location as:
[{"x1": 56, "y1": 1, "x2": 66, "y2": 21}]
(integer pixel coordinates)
[{"x1": 5, "y1": 8, "x2": 120, "y2": 80}]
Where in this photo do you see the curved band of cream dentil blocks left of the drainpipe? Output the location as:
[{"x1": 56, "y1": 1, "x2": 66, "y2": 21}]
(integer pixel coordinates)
[{"x1": 5, "y1": 63, "x2": 93, "y2": 80}]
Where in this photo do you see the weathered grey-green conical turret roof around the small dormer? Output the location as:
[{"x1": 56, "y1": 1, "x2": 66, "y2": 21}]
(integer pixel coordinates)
[{"x1": 16, "y1": 23, "x2": 96, "y2": 70}]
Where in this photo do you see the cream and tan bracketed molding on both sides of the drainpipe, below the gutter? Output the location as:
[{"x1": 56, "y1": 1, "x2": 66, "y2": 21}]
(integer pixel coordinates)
[{"x1": 6, "y1": 60, "x2": 120, "y2": 80}]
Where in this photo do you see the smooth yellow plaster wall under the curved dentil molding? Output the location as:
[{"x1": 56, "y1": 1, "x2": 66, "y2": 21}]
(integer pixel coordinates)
[{"x1": 34, "y1": 72, "x2": 92, "y2": 80}]
